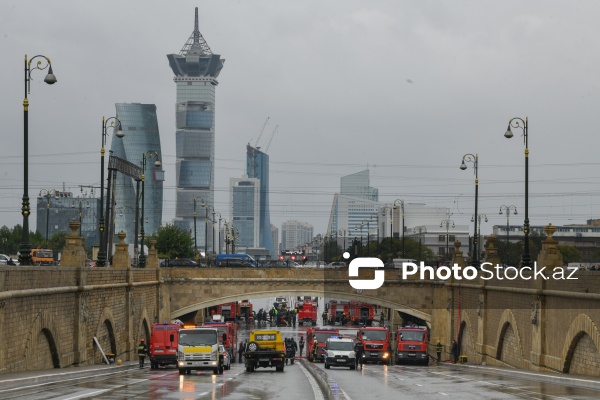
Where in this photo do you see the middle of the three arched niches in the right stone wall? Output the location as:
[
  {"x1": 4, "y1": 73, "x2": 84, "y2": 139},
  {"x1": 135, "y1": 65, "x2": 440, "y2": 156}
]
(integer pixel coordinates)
[{"x1": 496, "y1": 308, "x2": 525, "y2": 368}]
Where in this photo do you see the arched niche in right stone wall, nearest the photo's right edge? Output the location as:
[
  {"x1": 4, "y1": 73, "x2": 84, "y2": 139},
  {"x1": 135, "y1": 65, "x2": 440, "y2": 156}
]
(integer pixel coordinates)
[{"x1": 561, "y1": 314, "x2": 600, "y2": 374}]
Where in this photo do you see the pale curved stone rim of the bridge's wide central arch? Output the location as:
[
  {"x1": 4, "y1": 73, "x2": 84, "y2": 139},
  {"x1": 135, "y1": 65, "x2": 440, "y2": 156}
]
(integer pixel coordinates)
[{"x1": 170, "y1": 288, "x2": 431, "y2": 323}]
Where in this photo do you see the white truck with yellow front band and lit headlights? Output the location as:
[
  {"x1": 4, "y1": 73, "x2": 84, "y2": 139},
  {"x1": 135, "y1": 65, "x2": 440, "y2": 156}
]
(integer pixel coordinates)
[{"x1": 177, "y1": 326, "x2": 226, "y2": 375}]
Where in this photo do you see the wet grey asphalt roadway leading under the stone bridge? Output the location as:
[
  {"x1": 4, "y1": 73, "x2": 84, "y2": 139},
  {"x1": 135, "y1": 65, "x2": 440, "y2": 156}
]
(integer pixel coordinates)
[{"x1": 0, "y1": 327, "x2": 600, "y2": 400}]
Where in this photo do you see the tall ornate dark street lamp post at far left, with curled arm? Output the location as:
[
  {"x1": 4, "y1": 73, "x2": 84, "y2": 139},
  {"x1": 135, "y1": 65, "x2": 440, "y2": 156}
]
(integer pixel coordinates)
[{"x1": 19, "y1": 54, "x2": 56, "y2": 265}]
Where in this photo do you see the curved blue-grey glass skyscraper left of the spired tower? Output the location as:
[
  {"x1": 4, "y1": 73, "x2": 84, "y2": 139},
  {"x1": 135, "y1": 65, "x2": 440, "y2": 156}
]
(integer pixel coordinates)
[{"x1": 110, "y1": 103, "x2": 164, "y2": 243}]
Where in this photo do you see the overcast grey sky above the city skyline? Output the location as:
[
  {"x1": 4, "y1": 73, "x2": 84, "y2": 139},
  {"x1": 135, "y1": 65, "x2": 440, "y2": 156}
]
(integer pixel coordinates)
[{"x1": 0, "y1": 0, "x2": 600, "y2": 233}]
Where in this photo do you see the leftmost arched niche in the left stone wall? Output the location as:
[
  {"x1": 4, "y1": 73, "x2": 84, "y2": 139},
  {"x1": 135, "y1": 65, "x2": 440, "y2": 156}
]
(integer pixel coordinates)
[{"x1": 25, "y1": 311, "x2": 63, "y2": 369}]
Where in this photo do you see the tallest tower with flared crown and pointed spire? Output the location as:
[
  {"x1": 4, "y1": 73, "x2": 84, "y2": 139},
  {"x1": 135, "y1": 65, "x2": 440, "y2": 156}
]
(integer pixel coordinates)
[{"x1": 167, "y1": 7, "x2": 225, "y2": 252}]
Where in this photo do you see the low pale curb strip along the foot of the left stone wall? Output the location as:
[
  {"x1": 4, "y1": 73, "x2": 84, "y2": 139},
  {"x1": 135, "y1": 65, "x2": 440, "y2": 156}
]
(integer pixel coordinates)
[{"x1": 0, "y1": 363, "x2": 139, "y2": 388}]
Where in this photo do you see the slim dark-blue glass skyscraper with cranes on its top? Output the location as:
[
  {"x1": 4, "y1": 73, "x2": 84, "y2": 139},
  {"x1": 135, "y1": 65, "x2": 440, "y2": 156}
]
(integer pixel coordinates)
[{"x1": 246, "y1": 145, "x2": 275, "y2": 256}]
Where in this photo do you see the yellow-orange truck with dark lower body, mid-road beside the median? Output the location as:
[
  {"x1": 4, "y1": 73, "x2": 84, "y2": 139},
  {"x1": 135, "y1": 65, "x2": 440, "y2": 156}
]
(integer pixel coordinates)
[{"x1": 244, "y1": 329, "x2": 285, "y2": 372}]
